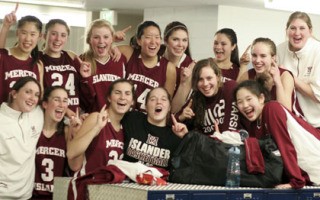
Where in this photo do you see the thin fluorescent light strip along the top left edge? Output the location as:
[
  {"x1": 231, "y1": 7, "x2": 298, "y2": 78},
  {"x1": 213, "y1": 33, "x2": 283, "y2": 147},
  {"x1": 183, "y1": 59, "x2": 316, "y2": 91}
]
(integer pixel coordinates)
[{"x1": 1, "y1": 0, "x2": 85, "y2": 8}]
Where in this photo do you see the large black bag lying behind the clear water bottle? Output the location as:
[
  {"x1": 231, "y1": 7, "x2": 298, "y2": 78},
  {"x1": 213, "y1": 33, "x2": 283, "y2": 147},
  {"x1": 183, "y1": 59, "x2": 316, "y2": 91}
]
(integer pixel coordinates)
[{"x1": 169, "y1": 131, "x2": 283, "y2": 188}]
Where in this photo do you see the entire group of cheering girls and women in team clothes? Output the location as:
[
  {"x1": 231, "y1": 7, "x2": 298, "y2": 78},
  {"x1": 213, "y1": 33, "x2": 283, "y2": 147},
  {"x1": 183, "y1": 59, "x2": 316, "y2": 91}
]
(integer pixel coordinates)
[{"x1": 0, "y1": 2, "x2": 320, "y2": 199}]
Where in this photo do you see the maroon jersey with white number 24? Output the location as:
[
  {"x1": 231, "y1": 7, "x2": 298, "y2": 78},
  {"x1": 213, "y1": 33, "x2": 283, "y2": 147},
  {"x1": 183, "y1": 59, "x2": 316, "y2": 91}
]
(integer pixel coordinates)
[{"x1": 40, "y1": 51, "x2": 80, "y2": 112}]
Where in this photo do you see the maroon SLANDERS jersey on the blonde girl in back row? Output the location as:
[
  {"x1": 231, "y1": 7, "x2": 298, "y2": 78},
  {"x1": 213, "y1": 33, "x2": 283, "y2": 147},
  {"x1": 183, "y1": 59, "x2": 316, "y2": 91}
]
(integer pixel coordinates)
[{"x1": 80, "y1": 55, "x2": 127, "y2": 113}]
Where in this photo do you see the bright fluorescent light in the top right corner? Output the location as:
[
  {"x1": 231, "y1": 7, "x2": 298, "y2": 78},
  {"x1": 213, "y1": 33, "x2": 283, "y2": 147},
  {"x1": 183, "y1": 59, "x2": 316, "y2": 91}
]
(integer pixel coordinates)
[{"x1": 264, "y1": 0, "x2": 320, "y2": 15}]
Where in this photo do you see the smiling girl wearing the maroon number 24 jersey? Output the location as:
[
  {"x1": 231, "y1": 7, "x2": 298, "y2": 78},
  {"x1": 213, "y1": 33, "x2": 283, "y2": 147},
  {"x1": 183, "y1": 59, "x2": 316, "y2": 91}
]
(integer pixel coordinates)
[{"x1": 40, "y1": 19, "x2": 80, "y2": 117}]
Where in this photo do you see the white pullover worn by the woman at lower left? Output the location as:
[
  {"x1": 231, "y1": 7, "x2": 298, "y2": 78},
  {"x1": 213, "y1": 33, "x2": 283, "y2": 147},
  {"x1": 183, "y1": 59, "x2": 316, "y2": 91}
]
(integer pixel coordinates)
[{"x1": 0, "y1": 103, "x2": 43, "y2": 200}]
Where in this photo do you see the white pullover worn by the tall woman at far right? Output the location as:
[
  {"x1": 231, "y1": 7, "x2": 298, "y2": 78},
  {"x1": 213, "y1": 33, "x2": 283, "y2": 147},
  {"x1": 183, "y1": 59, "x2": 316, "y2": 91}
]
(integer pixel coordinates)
[{"x1": 277, "y1": 37, "x2": 320, "y2": 128}]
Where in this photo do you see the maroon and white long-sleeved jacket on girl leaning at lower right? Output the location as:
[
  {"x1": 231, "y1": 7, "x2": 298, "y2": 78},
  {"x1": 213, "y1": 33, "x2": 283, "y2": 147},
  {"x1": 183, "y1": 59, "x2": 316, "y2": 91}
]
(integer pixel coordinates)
[{"x1": 249, "y1": 101, "x2": 320, "y2": 189}]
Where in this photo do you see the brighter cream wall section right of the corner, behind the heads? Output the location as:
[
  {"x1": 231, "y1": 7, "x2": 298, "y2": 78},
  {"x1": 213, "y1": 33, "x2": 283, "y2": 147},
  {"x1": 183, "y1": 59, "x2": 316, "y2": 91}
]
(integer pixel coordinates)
[{"x1": 218, "y1": 6, "x2": 320, "y2": 56}]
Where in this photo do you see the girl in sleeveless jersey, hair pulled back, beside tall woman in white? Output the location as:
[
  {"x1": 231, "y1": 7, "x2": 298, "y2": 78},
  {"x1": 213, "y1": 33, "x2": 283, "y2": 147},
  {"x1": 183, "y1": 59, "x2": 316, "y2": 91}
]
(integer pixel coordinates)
[{"x1": 240, "y1": 38, "x2": 302, "y2": 116}]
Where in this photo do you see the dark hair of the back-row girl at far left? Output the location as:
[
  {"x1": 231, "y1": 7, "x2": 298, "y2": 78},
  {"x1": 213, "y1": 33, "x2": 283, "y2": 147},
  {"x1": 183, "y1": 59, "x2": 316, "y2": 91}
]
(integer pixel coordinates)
[{"x1": 17, "y1": 15, "x2": 42, "y2": 65}]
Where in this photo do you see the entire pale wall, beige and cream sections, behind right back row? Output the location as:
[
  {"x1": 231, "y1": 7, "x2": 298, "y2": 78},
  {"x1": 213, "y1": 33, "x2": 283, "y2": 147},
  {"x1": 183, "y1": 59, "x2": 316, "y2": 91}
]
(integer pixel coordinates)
[{"x1": 144, "y1": 6, "x2": 320, "y2": 60}]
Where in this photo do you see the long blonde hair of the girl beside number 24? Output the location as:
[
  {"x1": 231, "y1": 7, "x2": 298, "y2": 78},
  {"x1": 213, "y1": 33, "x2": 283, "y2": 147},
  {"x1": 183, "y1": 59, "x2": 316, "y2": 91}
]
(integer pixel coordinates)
[{"x1": 83, "y1": 19, "x2": 115, "y2": 75}]
